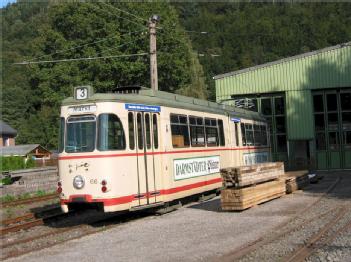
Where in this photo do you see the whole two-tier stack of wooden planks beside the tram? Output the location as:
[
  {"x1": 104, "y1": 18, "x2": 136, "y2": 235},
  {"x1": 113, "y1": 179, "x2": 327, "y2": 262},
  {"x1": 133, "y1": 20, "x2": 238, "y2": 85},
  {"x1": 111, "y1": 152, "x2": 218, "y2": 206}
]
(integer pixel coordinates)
[{"x1": 221, "y1": 162, "x2": 286, "y2": 211}]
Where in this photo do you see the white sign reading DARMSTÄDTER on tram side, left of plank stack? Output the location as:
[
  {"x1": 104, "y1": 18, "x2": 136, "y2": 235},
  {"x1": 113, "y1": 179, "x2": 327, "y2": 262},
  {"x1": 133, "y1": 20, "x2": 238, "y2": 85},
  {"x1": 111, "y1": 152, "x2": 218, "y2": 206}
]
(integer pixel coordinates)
[{"x1": 173, "y1": 156, "x2": 220, "y2": 180}]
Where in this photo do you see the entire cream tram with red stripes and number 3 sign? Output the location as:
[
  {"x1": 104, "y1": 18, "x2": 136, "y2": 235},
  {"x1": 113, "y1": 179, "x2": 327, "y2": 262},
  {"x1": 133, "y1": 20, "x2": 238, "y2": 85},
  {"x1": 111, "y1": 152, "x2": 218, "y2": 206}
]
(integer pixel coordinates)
[{"x1": 58, "y1": 87, "x2": 270, "y2": 212}]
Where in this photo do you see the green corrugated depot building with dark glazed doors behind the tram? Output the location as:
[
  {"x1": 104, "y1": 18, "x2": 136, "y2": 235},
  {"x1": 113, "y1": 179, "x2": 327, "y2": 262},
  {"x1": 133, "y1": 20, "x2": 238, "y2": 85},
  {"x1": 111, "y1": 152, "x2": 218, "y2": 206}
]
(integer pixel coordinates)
[{"x1": 214, "y1": 42, "x2": 351, "y2": 170}]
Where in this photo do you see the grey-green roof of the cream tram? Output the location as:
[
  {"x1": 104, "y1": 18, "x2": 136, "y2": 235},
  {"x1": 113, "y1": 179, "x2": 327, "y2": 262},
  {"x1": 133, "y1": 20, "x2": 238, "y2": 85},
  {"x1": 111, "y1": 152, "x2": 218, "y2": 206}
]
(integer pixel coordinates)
[{"x1": 62, "y1": 88, "x2": 265, "y2": 121}]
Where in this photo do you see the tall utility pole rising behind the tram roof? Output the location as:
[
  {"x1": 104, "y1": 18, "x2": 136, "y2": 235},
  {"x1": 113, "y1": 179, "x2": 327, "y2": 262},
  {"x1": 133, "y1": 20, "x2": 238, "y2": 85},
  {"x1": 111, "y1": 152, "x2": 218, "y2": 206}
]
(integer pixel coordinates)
[{"x1": 149, "y1": 15, "x2": 160, "y2": 90}]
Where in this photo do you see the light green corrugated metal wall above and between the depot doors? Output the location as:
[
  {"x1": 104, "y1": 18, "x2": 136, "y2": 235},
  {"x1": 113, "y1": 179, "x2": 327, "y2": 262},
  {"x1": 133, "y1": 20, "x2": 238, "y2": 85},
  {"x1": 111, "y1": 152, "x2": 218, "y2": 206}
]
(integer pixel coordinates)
[{"x1": 215, "y1": 43, "x2": 351, "y2": 140}]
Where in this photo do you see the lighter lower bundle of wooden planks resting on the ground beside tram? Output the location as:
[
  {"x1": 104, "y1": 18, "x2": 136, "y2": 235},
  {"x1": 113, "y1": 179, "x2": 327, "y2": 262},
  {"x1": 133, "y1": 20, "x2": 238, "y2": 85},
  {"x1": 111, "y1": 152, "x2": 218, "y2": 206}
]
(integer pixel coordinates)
[{"x1": 221, "y1": 179, "x2": 286, "y2": 211}]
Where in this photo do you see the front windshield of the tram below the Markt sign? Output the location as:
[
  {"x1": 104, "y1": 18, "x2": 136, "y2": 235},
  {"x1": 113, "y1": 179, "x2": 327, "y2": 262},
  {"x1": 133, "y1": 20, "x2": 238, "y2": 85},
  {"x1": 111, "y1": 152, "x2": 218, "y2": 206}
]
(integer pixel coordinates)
[{"x1": 65, "y1": 115, "x2": 96, "y2": 153}]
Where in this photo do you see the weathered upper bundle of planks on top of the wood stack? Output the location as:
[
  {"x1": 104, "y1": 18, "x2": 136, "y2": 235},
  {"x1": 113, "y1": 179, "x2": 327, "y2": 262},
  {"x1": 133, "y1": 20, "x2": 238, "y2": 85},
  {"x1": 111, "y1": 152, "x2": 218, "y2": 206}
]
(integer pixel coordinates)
[{"x1": 221, "y1": 162, "x2": 284, "y2": 188}]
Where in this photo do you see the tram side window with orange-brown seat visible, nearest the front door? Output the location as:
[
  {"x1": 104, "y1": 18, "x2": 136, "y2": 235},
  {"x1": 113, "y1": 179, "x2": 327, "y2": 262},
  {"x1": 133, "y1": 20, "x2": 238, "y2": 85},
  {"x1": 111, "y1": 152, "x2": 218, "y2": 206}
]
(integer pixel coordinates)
[{"x1": 170, "y1": 114, "x2": 190, "y2": 147}]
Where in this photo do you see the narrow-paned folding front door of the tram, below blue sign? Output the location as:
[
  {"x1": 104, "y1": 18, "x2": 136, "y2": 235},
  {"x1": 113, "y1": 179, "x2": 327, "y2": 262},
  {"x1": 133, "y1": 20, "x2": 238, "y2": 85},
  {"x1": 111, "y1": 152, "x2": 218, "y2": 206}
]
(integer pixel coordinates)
[{"x1": 133, "y1": 112, "x2": 161, "y2": 205}]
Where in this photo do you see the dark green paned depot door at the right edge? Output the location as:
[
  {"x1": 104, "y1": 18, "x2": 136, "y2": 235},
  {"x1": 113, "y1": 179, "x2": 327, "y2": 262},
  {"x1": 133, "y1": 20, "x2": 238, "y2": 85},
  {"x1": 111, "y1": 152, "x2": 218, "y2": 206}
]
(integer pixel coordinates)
[{"x1": 313, "y1": 89, "x2": 351, "y2": 169}]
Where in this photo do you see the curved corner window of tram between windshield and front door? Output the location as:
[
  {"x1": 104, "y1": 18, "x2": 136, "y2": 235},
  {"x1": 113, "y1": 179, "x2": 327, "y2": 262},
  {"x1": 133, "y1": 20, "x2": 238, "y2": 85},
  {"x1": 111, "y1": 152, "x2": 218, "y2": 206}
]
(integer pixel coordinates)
[{"x1": 97, "y1": 114, "x2": 126, "y2": 151}]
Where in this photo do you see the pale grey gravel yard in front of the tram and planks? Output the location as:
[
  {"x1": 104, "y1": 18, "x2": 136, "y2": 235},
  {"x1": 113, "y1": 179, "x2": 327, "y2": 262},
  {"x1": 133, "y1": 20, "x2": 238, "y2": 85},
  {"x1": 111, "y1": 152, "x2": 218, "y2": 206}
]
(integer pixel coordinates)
[{"x1": 4, "y1": 171, "x2": 351, "y2": 262}]
